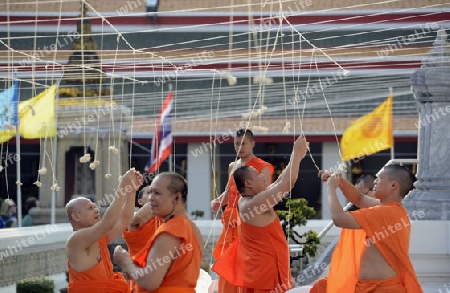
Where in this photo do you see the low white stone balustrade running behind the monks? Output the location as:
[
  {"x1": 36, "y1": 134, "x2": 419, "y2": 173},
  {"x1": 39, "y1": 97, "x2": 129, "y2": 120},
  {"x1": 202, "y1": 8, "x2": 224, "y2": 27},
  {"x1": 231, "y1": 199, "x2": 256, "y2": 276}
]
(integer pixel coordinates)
[{"x1": 0, "y1": 220, "x2": 450, "y2": 291}]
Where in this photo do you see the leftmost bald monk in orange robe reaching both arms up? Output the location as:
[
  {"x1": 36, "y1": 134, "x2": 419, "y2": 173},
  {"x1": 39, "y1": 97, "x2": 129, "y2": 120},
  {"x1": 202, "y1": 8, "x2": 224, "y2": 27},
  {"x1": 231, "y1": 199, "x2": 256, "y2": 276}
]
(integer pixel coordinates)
[{"x1": 66, "y1": 169, "x2": 143, "y2": 293}]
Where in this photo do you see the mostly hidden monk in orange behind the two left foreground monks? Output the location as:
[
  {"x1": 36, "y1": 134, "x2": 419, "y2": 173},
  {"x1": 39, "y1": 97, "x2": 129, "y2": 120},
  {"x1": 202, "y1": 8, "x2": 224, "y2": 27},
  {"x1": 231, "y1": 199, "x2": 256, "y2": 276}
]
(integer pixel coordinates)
[{"x1": 122, "y1": 186, "x2": 161, "y2": 293}]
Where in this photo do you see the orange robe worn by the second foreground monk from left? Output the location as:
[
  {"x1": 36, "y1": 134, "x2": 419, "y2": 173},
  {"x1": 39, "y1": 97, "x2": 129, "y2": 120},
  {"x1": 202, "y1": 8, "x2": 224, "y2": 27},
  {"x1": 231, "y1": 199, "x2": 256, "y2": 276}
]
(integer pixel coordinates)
[{"x1": 134, "y1": 216, "x2": 202, "y2": 293}]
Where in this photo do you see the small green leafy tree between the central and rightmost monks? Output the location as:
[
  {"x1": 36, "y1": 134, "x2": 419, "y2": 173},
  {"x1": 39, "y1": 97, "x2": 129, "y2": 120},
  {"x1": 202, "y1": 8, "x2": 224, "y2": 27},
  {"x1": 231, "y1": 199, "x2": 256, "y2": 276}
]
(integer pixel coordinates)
[{"x1": 277, "y1": 198, "x2": 320, "y2": 257}]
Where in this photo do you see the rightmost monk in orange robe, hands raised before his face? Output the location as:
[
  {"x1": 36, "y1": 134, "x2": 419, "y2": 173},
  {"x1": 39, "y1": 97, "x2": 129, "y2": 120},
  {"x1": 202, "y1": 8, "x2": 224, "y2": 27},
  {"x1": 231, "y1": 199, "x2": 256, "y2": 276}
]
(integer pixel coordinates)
[{"x1": 327, "y1": 165, "x2": 423, "y2": 293}]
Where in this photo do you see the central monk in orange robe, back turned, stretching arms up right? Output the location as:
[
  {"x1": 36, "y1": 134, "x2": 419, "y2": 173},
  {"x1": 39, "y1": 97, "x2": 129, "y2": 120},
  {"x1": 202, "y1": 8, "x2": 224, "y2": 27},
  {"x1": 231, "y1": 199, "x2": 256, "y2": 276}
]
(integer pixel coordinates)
[{"x1": 212, "y1": 137, "x2": 308, "y2": 293}]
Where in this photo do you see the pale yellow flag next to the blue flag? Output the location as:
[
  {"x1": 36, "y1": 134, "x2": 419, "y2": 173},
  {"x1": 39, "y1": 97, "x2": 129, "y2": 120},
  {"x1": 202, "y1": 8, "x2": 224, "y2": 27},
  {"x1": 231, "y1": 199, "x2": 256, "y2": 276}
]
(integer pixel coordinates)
[{"x1": 19, "y1": 84, "x2": 57, "y2": 139}]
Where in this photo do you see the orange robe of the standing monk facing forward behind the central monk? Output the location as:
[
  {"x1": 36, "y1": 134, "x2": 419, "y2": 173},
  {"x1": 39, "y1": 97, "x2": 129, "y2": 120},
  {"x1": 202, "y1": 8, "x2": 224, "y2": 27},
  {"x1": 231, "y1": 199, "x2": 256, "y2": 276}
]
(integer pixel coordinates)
[{"x1": 213, "y1": 157, "x2": 274, "y2": 260}]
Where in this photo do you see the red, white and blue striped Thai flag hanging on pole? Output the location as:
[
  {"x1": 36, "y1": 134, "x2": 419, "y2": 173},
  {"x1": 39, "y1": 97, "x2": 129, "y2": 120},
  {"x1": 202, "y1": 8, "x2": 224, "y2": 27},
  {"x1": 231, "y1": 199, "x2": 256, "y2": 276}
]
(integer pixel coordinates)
[{"x1": 145, "y1": 91, "x2": 172, "y2": 173}]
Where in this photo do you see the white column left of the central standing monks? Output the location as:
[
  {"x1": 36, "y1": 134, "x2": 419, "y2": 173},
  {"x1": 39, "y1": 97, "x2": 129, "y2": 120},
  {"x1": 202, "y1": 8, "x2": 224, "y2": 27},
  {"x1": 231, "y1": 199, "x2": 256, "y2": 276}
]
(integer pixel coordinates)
[{"x1": 186, "y1": 143, "x2": 212, "y2": 219}]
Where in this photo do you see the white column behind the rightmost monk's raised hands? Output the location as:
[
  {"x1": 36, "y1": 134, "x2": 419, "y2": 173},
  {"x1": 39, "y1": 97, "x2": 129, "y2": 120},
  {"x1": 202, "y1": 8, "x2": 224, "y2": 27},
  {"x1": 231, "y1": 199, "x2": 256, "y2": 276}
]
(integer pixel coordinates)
[{"x1": 322, "y1": 142, "x2": 349, "y2": 219}]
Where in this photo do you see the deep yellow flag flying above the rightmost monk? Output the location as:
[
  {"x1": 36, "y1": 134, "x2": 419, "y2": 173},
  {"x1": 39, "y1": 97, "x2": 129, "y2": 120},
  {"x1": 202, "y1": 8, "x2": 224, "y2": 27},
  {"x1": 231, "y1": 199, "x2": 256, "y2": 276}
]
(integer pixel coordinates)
[{"x1": 341, "y1": 96, "x2": 394, "y2": 161}]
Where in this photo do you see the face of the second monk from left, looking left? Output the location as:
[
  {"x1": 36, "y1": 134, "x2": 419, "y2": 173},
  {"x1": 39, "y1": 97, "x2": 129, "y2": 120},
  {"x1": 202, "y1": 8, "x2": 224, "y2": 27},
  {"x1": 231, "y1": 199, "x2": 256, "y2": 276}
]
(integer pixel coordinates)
[{"x1": 149, "y1": 176, "x2": 176, "y2": 217}]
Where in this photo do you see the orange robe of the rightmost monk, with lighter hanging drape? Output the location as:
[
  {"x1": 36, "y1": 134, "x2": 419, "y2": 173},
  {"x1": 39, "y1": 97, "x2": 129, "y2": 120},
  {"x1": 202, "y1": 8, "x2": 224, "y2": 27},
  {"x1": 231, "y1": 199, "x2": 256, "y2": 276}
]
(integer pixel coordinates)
[{"x1": 327, "y1": 202, "x2": 423, "y2": 293}]
